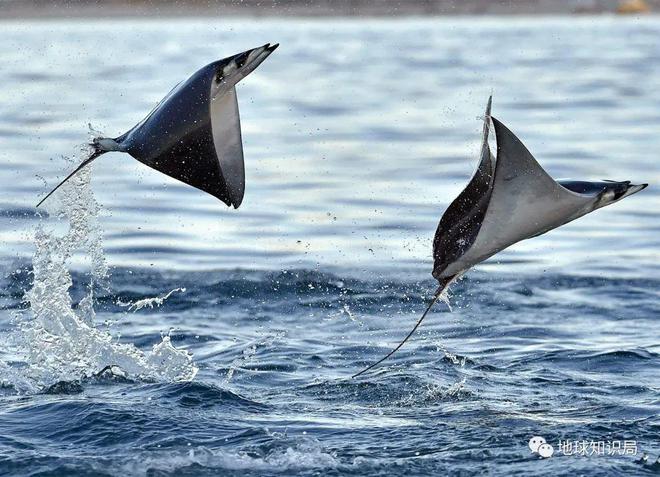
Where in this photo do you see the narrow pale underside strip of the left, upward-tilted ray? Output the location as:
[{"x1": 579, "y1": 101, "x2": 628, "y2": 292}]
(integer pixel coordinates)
[{"x1": 211, "y1": 88, "x2": 245, "y2": 207}]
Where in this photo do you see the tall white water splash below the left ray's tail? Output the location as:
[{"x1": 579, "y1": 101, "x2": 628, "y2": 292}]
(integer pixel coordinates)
[{"x1": 3, "y1": 160, "x2": 197, "y2": 392}]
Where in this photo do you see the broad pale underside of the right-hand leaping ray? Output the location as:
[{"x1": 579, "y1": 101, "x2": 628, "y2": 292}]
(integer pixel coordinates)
[{"x1": 448, "y1": 118, "x2": 597, "y2": 272}]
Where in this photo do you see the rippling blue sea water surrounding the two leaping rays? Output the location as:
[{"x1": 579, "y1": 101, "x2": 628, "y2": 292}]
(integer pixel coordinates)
[{"x1": 0, "y1": 17, "x2": 660, "y2": 476}]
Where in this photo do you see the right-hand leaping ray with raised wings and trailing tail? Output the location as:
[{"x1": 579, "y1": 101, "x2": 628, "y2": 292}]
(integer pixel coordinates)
[{"x1": 353, "y1": 97, "x2": 648, "y2": 377}]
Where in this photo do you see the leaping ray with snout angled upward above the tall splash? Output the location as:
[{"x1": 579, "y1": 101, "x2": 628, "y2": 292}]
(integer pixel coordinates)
[{"x1": 37, "y1": 44, "x2": 278, "y2": 209}]
